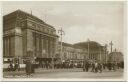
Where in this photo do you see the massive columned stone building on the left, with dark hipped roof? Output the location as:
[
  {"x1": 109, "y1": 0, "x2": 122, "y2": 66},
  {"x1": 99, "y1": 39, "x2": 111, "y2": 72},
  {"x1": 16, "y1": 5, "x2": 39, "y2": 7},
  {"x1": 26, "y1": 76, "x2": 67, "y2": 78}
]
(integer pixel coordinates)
[{"x1": 3, "y1": 10, "x2": 58, "y2": 61}]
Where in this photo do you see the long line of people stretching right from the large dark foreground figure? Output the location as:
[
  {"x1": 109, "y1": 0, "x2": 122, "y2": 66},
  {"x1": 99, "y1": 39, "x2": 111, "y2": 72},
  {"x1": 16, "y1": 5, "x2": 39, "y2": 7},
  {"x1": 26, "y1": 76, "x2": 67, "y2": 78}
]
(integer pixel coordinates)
[{"x1": 33, "y1": 60, "x2": 123, "y2": 73}]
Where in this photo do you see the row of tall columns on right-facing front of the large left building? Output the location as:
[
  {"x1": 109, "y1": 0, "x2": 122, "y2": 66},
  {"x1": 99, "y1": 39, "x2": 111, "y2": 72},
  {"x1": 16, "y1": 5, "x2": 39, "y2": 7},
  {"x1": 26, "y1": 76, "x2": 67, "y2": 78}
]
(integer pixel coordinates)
[{"x1": 34, "y1": 33, "x2": 55, "y2": 58}]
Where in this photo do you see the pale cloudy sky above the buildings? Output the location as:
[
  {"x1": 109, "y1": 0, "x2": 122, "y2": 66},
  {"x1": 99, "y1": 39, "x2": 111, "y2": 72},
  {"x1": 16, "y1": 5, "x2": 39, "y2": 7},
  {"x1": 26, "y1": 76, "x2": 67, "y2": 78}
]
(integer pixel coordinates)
[{"x1": 2, "y1": 1, "x2": 125, "y2": 51}]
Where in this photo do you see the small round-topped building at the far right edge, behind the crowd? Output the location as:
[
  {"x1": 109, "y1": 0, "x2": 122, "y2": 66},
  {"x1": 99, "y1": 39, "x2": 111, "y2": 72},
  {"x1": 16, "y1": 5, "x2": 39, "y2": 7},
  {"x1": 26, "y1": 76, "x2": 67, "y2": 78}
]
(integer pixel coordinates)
[{"x1": 108, "y1": 51, "x2": 124, "y2": 62}]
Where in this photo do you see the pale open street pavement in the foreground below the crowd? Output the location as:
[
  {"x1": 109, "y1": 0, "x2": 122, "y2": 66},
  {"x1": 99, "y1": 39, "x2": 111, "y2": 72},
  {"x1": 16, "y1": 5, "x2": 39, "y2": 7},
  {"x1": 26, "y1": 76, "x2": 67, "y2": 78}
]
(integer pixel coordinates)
[{"x1": 3, "y1": 68, "x2": 123, "y2": 79}]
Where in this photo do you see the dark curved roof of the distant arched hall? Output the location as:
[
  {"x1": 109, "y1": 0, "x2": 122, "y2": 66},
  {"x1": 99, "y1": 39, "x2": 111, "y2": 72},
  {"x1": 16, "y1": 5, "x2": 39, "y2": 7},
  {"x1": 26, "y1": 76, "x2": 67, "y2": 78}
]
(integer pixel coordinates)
[{"x1": 74, "y1": 41, "x2": 102, "y2": 51}]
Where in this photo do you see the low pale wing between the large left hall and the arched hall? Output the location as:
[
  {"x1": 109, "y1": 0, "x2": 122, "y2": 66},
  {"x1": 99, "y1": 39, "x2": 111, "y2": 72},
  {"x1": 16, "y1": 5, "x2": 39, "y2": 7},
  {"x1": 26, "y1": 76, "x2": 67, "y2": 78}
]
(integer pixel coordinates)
[{"x1": 57, "y1": 42, "x2": 87, "y2": 61}]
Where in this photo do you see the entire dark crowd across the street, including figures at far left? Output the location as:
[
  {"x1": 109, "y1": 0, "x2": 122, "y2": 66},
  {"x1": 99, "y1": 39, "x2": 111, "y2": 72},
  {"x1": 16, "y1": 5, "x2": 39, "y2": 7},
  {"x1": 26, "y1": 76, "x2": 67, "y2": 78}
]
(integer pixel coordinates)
[{"x1": 8, "y1": 59, "x2": 124, "y2": 76}]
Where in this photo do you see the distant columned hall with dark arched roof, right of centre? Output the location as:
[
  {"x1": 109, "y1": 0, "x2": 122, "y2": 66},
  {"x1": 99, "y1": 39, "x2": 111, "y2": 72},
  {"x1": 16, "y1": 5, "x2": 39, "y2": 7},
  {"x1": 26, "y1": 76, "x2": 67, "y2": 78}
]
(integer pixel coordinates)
[{"x1": 74, "y1": 41, "x2": 108, "y2": 62}]
